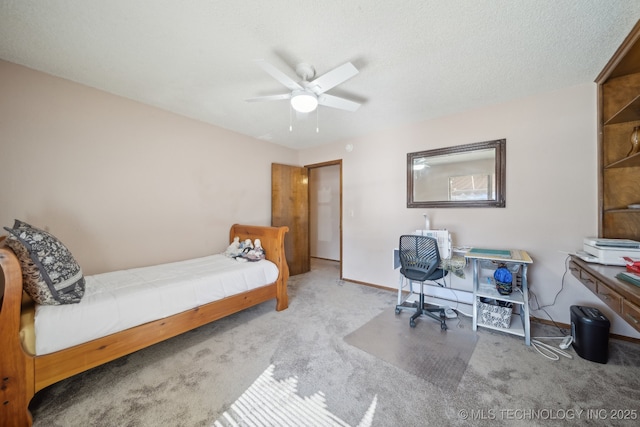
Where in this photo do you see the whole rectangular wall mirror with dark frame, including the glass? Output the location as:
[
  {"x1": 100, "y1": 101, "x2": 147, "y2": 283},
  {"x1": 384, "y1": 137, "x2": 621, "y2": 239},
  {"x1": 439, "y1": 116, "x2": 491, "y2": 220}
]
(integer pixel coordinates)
[{"x1": 407, "y1": 139, "x2": 507, "y2": 208}]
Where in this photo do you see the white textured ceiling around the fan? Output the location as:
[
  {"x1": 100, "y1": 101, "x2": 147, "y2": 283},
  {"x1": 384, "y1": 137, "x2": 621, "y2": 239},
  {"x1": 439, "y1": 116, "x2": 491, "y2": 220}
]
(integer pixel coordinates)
[{"x1": 0, "y1": 0, "x2": 640, "y2": 149}]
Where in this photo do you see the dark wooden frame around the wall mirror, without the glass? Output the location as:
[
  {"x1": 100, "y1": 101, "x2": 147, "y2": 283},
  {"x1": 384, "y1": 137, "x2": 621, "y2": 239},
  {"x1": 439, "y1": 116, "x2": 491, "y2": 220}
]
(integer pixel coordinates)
[{"x1": 407, "y1": 139, "x2": 507, "y2": 208}]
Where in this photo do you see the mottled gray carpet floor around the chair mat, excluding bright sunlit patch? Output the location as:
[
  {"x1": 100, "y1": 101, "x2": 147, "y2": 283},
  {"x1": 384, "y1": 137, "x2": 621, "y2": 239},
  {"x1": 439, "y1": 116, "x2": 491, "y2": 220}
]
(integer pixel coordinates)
[{"x1": 28, "y1": 260, "x2": 640, "y2": 427}]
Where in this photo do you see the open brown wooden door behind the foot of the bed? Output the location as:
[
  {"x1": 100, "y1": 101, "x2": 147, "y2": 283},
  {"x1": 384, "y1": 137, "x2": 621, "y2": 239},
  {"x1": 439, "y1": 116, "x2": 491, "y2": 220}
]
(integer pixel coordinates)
[{"x1": 271, "y1": 163, "x2": 311, "y2": 276}]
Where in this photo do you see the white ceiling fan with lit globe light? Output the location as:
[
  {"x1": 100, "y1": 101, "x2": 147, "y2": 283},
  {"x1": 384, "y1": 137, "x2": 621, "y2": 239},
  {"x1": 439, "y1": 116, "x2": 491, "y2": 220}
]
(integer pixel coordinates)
[{"x1": 247, "y1": 59, "x2": 360, "y2": 113}]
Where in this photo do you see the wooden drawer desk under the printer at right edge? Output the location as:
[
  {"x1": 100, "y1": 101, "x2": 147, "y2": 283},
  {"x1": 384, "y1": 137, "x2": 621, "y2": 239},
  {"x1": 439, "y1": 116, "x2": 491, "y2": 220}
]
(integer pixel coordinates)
[{"x1": 569, "y1": 256, "x2": 640, "y2": 331}]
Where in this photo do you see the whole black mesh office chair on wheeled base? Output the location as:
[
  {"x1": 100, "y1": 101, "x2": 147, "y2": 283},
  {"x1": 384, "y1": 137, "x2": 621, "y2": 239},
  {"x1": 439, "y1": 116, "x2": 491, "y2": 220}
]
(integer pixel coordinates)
[{"x1": 396, "y1": 235, "x2": 447, "y2": 330}]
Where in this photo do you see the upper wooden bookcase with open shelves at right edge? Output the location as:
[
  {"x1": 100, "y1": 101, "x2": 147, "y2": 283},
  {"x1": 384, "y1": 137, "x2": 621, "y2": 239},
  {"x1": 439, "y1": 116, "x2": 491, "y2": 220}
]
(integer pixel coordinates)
[{"x1": 596, "y1": 21, "x2": 640, "y2": 240}]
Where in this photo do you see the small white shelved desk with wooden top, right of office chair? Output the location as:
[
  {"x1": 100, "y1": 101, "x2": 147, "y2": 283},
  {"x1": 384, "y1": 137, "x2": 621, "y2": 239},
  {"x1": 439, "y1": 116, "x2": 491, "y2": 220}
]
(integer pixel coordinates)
[{"x1": 465, "y1": 248, "x2": 533, "y2": 345}]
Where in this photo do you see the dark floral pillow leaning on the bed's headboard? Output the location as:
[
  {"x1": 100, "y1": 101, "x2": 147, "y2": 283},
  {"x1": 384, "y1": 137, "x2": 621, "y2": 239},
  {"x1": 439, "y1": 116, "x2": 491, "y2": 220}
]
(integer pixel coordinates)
[{"x1": 4, "y1": 220, "x2": 85, "y2": 305}]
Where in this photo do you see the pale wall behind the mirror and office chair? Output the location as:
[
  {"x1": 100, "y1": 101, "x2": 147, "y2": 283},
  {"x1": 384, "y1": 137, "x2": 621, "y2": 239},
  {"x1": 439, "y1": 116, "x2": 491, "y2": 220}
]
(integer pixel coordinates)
[{"x1": 299, "y1": 84, "x2": 640, "y2": 337}]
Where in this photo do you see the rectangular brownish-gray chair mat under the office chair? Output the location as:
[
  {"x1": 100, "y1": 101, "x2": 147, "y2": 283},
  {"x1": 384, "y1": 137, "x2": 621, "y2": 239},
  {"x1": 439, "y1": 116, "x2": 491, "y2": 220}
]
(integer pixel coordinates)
[{"x1": 345, "y1": 310, "x2": 478, "y2": 392}]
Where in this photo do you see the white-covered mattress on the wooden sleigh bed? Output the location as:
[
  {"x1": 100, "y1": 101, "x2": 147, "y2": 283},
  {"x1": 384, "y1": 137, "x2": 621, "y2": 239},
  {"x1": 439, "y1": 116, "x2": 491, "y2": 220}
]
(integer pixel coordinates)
[{"x1": 35, "y1": 255, "x2": 278, "y2": 355}]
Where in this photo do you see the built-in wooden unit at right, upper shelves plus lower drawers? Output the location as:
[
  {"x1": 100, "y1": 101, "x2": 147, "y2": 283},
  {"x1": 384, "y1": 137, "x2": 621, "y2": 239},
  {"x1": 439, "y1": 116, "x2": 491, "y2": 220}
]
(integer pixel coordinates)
[{"x1": 569, "y1": 21, "x2": 640, "y2": 331}]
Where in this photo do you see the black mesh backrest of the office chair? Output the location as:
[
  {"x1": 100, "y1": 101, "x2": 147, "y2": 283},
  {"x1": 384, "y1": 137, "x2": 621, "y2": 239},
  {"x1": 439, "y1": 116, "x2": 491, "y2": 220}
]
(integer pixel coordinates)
[{"x1": 399, "y1": 235, "x2": 443, "y2": 282}]
